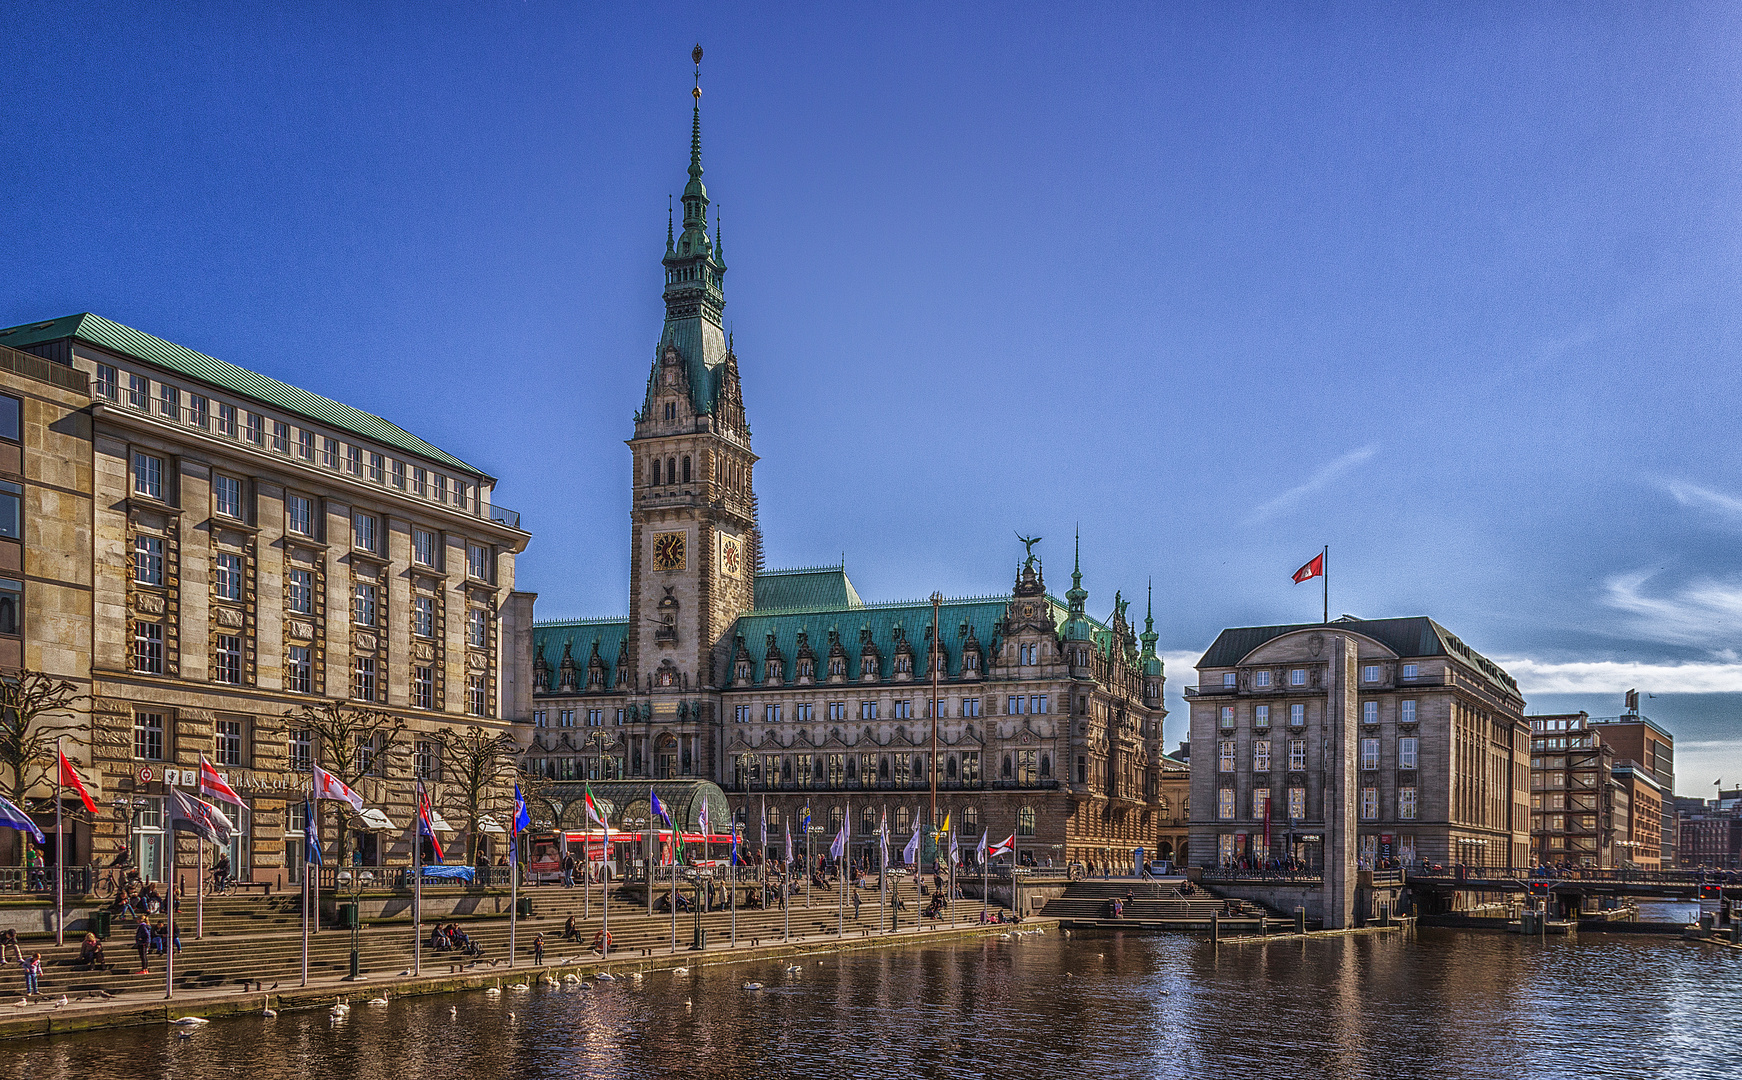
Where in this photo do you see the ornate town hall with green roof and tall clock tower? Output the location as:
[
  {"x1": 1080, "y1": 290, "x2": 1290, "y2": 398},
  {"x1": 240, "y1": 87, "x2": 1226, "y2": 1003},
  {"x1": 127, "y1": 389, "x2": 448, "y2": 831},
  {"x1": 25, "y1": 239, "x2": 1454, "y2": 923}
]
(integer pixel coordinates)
[{"x1": 521, "y1": 71, "x2": 1185, "y2": 866}]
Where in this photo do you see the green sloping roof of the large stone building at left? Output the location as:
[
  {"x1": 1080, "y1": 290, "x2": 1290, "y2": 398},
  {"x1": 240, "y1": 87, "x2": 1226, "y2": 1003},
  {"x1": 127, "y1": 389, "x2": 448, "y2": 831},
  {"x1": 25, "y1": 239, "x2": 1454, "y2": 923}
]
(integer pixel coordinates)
[{"x1": 0, "y1": 312, "x2": 490, "y2": 477}]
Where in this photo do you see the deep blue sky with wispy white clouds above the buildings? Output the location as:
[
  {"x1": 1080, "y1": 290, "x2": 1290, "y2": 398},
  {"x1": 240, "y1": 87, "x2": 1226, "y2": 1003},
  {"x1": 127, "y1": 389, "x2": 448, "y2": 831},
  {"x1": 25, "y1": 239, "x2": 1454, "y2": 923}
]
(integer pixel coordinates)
[{"x1": 0, "y1": 2, "x2": 1742, "y2": 794}]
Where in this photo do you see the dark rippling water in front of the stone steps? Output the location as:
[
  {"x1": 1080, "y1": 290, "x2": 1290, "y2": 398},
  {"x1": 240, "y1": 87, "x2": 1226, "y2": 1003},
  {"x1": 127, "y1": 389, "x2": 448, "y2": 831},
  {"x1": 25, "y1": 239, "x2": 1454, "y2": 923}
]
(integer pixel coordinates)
[{"x1": 0, "y1": 930, "x2": 1742, "y2": 1080}]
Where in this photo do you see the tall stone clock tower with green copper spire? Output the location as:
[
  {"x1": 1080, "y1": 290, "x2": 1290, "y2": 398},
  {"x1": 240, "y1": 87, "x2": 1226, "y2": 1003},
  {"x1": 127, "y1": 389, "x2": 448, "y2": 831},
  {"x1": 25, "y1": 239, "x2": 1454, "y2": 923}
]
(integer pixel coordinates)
[{"x1": 629, "y1": 45, "x2": 760, "y2": 703}]
